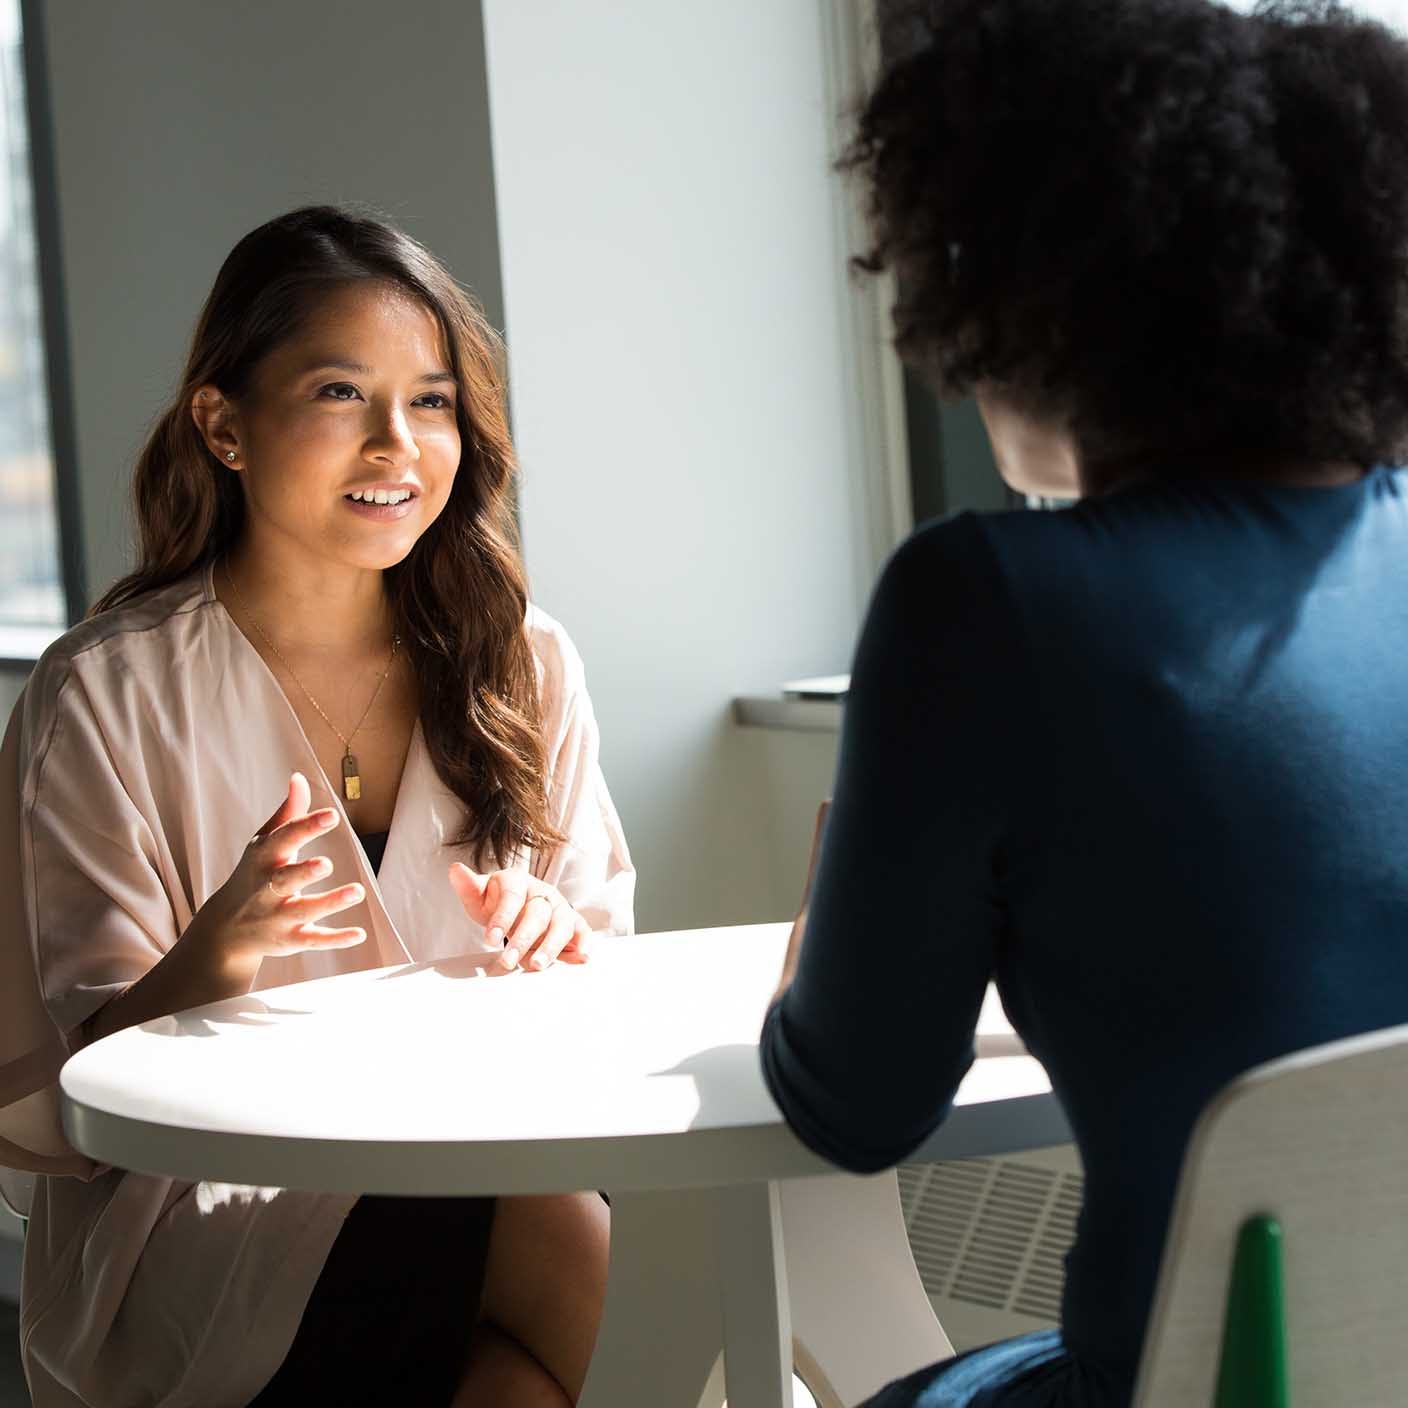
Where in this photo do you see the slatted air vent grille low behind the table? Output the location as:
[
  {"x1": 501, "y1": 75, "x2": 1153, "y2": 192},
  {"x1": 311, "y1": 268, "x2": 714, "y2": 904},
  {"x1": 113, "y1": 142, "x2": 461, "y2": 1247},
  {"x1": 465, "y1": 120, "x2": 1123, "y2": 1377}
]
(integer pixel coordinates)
[{"x1": 900, "y1": 1159, "x2": 1084, "y2": 1322}]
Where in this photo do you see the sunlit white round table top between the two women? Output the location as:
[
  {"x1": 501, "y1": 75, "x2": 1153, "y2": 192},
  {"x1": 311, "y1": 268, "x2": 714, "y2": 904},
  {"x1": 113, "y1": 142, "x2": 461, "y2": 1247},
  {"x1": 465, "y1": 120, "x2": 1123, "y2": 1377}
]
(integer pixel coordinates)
[{"x1": 61, "y1": 924, "x2": 1069, "y2": 1194}]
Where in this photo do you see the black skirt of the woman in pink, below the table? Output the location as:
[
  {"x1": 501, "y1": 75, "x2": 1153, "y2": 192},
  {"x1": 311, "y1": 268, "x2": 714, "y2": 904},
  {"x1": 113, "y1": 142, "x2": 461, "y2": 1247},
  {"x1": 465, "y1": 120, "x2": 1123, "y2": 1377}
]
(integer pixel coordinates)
[{"x1": 251, "y1": 1197, "x2": 496, "y2": 1408}]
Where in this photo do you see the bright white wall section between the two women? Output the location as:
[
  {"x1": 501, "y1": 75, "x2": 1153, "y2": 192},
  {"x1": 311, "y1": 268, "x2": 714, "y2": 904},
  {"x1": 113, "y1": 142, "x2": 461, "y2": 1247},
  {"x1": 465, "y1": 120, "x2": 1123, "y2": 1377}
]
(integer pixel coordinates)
[{"x1": 484, "y1": 0, "x2": 869, "y2": 928}]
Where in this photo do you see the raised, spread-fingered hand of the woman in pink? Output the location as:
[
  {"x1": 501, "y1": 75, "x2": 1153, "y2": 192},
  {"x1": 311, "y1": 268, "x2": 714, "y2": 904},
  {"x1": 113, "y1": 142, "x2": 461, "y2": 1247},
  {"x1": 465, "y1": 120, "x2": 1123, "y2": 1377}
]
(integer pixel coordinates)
[{"x1": 200, "y1": 773, "x2": 366, "y2": 969}]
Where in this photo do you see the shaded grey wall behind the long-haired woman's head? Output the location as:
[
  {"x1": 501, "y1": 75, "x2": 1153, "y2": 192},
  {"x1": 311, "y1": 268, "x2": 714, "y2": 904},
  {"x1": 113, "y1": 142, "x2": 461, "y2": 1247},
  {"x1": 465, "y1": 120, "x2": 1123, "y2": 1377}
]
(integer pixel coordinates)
[{"x1": 37, "y1": 0, "x2": 503, "y2": 597}]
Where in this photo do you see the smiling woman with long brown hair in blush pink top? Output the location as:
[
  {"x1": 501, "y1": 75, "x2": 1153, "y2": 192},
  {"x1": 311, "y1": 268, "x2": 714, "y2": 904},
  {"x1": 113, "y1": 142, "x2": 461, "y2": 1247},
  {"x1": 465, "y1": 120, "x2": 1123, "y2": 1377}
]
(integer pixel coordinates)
[{"x1": 0, "y1": 207, "x2": 634, "y2": 1408}]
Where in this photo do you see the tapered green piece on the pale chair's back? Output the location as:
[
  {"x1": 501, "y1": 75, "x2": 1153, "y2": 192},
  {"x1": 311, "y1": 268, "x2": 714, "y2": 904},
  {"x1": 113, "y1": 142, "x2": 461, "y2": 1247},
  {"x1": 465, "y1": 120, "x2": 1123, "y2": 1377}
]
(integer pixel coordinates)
[{"x1": 1214, "y1": 1215, "x2": 1291, "y2": 1408}]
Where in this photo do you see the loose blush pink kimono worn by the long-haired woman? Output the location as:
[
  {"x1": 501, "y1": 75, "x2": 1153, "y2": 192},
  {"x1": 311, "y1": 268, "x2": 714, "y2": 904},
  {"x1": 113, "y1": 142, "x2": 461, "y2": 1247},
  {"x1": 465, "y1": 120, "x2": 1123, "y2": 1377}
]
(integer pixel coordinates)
[{"x1": 0, "y1": 569, "x2": 635, "y2": 1408}]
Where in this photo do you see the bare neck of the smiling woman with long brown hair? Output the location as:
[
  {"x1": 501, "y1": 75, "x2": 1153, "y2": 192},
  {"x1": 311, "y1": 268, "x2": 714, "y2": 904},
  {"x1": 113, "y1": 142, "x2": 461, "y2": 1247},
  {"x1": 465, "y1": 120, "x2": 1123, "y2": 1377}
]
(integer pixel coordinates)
[{"x1": 214, "y1": 543, "x2": 394, "y2": 659}]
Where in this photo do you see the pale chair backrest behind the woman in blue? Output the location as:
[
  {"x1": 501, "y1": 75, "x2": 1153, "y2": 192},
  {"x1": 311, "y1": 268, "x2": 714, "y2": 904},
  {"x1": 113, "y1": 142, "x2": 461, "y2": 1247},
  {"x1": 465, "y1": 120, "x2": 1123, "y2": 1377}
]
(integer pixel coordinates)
[{"x1": 1135, "y1": 1026, "x2": 1408, "y2": 1408}]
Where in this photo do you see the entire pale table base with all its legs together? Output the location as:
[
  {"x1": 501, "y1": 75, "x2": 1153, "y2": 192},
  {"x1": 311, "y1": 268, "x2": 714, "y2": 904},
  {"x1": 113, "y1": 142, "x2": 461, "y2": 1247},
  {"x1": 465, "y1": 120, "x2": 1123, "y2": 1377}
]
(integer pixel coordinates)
[{"x1": 579, "y1": 1173, "x2": 953, "y2": 1408}]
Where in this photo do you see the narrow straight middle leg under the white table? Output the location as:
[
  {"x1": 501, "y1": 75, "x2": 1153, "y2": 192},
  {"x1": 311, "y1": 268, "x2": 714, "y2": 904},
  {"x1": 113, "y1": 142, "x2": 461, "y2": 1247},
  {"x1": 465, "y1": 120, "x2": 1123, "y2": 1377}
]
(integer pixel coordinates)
[{"x1": 714, "y1": 1183, "x2": 793, "y2": 1408}]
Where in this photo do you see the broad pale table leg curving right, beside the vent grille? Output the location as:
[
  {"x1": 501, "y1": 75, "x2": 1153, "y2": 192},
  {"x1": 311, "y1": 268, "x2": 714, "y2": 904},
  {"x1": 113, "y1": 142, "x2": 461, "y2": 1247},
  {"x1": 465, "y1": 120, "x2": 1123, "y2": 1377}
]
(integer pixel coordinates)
[{"x1": 782, "y1": 1171, "x2": 953, "y2": 1408}]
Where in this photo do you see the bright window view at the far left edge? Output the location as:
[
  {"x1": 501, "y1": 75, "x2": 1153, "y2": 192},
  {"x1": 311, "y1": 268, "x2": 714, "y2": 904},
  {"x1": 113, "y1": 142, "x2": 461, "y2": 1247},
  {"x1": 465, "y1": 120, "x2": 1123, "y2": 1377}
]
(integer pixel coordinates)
[{"x1": 0, "y1": 0, "x2": 65, "y2": 627}]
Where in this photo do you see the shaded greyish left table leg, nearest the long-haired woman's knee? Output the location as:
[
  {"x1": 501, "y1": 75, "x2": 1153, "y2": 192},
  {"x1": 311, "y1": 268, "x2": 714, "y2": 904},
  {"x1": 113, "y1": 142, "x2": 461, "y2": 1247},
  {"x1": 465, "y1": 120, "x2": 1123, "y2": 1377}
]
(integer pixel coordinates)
[{"x1": 577, "y1": 1188, "x2": 724, "y2": 1408}]
